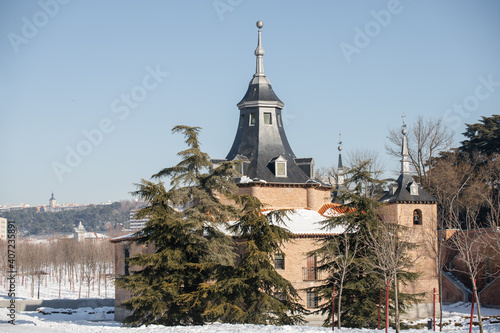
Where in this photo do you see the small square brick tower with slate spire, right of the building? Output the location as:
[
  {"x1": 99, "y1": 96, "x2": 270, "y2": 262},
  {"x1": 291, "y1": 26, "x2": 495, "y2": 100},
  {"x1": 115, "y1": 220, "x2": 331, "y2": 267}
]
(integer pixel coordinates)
[{"x1": 380, "y1": 116, "x2": 438, "y2": 317}]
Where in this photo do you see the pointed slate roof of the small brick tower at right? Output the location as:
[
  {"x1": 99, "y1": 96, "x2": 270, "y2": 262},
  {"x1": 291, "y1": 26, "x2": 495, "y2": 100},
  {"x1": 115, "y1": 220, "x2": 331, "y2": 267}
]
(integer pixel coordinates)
[{"x1": 380, "y1": 114, "x2": 437, "y2": 203}]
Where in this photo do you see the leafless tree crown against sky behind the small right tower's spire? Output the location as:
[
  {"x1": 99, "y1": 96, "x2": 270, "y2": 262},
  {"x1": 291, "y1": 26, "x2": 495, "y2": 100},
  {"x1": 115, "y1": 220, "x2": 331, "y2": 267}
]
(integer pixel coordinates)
[{"x1": 385, "y1": 116, "x2": 455, "y2": 185}]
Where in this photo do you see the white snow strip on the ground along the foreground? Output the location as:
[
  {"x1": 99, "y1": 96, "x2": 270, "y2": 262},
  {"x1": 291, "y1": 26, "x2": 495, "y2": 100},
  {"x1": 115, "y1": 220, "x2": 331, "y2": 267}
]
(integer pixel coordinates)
[{"x1": 0, "y1": 303, "x2": 500, "y2": 333}]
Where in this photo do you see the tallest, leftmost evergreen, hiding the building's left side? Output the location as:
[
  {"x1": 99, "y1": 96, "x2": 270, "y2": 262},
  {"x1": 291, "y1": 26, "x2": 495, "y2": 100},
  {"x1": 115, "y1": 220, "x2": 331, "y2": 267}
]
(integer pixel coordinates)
[{"x1": 117, "y1": 126, "x2": 242, "y2": 326}]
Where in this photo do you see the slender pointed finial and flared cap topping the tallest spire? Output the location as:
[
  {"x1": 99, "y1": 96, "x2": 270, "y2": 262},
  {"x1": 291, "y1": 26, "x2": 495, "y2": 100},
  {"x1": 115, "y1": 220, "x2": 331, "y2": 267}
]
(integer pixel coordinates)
[{"x1": 237, "y1": 21, "x2": 285, "y2": 110}]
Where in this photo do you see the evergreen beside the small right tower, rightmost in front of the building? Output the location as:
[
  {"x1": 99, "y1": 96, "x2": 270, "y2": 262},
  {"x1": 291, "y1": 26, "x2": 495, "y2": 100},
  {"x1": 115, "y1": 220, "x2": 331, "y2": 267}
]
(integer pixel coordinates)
[{"x1": 308, "y1": 161, "x2": 415, "y2": 328}]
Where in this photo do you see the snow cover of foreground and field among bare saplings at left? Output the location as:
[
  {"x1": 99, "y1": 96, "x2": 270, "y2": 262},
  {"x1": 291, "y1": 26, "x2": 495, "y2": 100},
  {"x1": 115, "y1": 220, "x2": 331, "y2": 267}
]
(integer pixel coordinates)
[{"x1": 0, "y1": 274, "x2": 500, "y2": 333}]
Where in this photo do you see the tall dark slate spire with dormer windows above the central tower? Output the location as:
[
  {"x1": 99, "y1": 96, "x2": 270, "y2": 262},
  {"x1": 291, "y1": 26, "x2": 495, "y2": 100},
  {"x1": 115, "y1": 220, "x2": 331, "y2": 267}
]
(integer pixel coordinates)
[{"x1": 226, "y1": 21, "x2": 317, "y2": 183}]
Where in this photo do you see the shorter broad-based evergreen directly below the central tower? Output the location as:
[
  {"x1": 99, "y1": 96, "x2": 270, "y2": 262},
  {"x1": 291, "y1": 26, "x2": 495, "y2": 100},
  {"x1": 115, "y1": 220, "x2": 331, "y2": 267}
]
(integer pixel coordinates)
[{"x1": 205, "y1": 196, "x2": 306, "y2": 325}]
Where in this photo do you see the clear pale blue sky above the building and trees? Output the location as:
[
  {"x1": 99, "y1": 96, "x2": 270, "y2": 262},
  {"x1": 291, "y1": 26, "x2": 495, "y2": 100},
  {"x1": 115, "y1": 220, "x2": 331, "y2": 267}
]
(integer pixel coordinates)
[{"x1": 0, "y1": 0, "x2": 500, "y2": 205}]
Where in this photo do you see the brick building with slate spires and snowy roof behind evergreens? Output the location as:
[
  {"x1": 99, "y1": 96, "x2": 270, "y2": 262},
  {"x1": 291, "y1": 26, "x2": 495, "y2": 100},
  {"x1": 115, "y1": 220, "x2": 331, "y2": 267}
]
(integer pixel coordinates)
[{"x1": 112, "y1": 21, "x2": 437, "y2": 321}]
